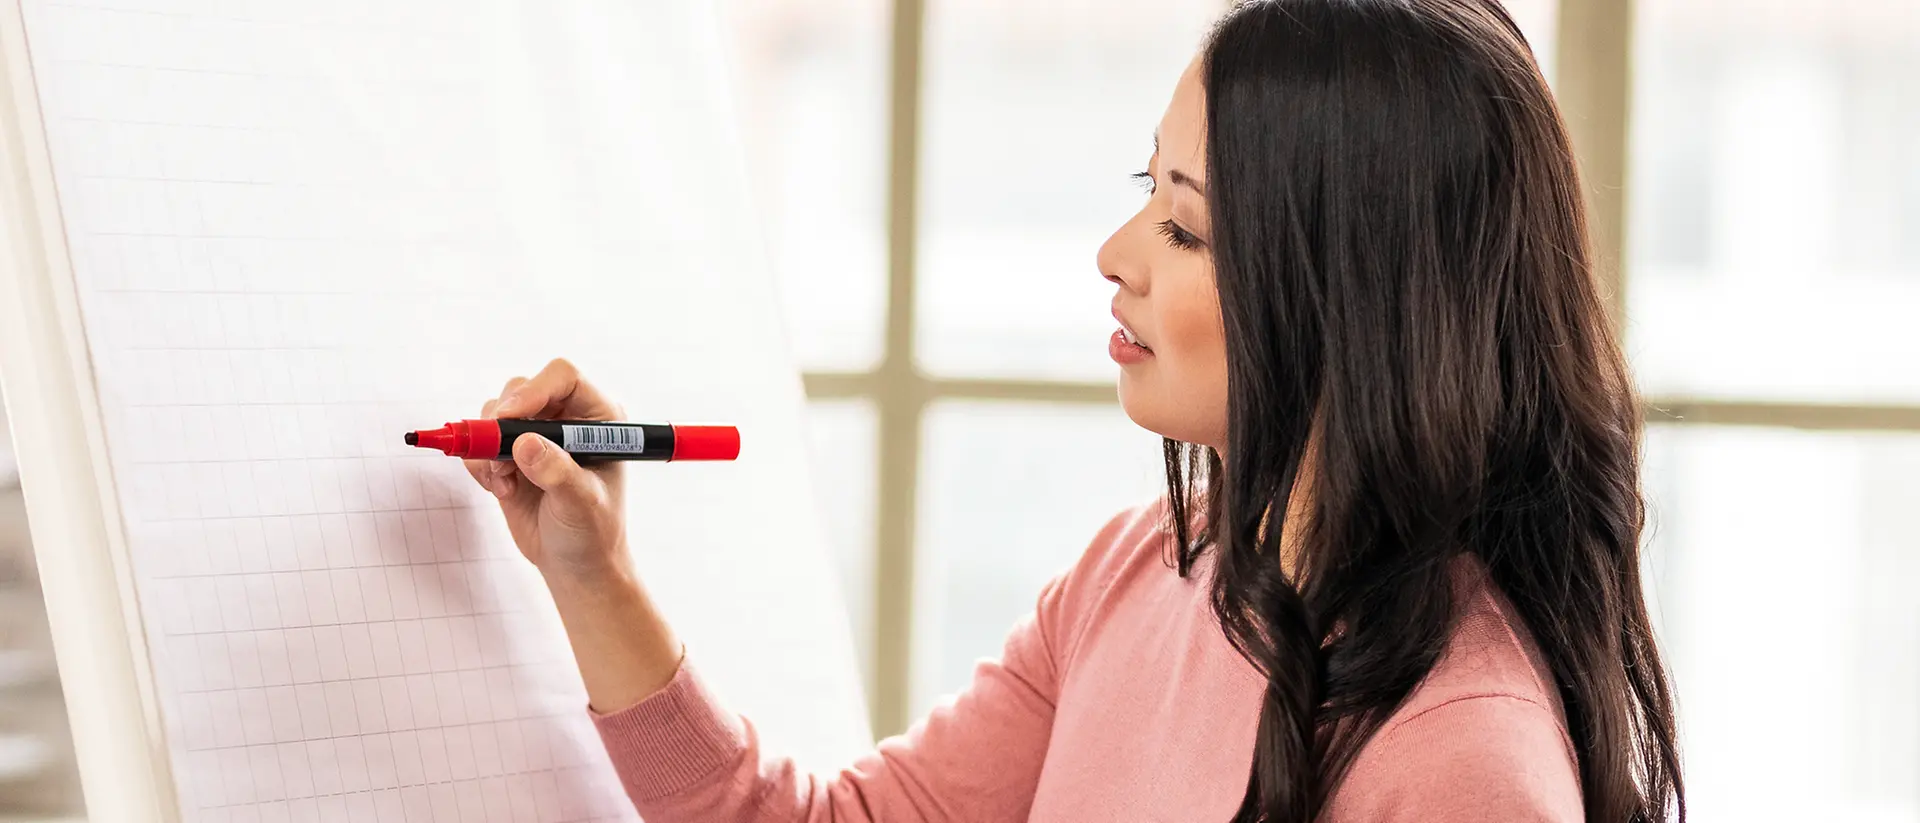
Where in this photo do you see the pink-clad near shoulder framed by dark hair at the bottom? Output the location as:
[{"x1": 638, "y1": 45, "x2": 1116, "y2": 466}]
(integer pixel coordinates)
[{"x1": 1323, "y1": 560, "x2": 1584, "y2": 823}]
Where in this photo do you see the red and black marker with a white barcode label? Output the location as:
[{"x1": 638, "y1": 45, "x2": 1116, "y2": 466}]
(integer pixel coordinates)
[{"x1": 407, "y1": 420, "x2": 739, "y2": 460}]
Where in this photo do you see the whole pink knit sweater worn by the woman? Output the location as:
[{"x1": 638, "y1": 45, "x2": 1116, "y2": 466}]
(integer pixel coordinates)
[{"x1": 595, "y1": 506, "x2": 1584, "y2": 823}]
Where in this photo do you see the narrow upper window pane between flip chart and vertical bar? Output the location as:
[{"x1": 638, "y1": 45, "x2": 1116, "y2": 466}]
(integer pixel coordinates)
[{"x1": 720, "y1": 0, "x2": 891, "y2": 370}]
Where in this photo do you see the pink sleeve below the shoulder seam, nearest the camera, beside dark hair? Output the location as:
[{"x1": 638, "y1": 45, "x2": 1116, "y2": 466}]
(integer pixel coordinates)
[{"x1": 1323, "y1": 694, "x2": 1586, "y2": 823}]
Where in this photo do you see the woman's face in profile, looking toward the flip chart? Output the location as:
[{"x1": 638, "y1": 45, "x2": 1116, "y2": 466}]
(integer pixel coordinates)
[{"x1": 1100, "y1": 59, "x2": 1227, "y2": 449}]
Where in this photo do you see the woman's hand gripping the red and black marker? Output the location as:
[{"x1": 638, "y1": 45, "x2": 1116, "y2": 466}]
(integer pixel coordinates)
[{"x1": 467, "y1": 361, "x2": 626, "y2": 581}]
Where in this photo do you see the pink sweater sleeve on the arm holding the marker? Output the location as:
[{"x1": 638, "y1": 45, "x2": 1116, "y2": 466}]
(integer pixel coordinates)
[{"x1": 593, "y1": 506, "x2": 1144, "y2": 823}]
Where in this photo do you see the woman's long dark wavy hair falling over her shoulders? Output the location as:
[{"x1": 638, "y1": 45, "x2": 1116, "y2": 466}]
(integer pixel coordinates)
[{"x1": 1165, "y1": 0, "x2": 1686, "y2": 823}]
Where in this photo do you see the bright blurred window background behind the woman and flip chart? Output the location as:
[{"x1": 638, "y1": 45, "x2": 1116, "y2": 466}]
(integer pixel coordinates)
[{"x1": 0, "y1": 0, "x2": 1920, "y2": 823}]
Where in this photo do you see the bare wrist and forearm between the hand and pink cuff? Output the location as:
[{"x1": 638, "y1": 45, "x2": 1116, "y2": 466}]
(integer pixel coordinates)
[{"x1": 543, "y1": 551, "x2": 682, "y2": 714}]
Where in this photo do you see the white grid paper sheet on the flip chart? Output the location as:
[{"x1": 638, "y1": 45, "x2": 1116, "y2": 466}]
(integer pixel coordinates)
[{"x1": 23, "y1": 0, "x2": 866, "y2": 823}]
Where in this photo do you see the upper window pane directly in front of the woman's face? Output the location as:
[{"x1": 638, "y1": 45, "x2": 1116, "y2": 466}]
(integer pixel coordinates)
[{"x1": 916, "y1": 0, "x2": 1221, "y2": 382}]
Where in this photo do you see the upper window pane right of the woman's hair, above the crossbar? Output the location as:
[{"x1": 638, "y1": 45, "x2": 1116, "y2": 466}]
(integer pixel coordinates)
[{"x1": 1626, "y1": 0, "x2": 1920, "y2": 403}]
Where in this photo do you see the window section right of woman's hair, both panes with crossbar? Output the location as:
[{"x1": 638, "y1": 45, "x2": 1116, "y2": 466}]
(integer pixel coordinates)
[{"x1": 1624, "y1": 0, "x2": 1920, "y2": 823}]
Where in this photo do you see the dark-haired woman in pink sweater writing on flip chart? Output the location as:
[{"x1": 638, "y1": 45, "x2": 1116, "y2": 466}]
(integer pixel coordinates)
[{"x1": 470, "y1": 0, "x2": 1684, "y2": 823}]
